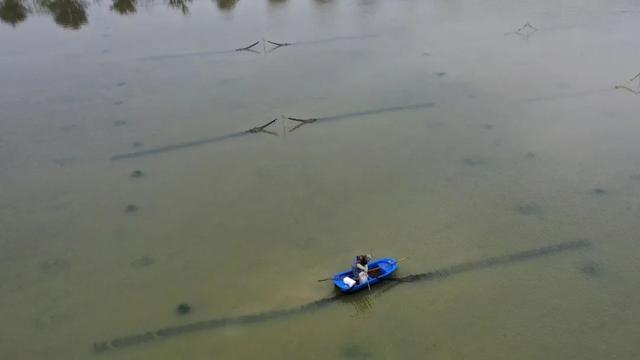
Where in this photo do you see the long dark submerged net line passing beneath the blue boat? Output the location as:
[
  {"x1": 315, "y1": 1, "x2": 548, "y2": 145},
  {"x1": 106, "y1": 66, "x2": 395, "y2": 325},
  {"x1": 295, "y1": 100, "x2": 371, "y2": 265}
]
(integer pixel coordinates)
[{"x1": 93, "y1": 240, "x2": 591, "y2": 352}]
